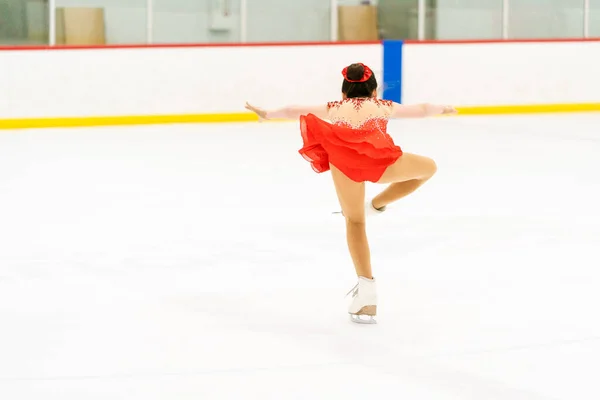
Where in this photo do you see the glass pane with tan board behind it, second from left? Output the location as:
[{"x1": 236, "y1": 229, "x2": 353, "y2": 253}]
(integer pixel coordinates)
[{"x1": 56, "y1": 0, "x2": 147, "y2": 45}]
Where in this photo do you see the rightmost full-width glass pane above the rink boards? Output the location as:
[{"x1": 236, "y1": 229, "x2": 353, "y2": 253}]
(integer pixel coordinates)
[{"x1": 508, "y1": 0, "x2": 583, "y2": 39}]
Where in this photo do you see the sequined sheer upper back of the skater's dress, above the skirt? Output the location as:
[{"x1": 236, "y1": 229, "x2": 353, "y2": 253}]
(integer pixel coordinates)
[{"x1": 327, "y1": 98, "x2": 393, "y2": 132}]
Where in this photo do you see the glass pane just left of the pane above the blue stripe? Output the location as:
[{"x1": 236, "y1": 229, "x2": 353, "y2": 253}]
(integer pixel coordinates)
[{"x1": 247, "y1": 0, "x2": 331, "y2": 42}]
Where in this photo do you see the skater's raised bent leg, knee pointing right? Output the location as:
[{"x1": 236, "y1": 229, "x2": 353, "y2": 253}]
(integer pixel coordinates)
[{"x1": 372, "y1": 153, "x2": 437, "y2": 209}]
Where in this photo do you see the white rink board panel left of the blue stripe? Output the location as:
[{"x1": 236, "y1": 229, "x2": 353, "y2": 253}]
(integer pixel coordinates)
[{"x1": 0, "y1": 44, "x2": 383, "y2": 118}]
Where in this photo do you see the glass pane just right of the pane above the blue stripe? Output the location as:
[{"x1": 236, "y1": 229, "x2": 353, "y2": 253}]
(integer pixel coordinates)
[{"x1": 426, "y1": 0, "x2": 504, "y2": 40}]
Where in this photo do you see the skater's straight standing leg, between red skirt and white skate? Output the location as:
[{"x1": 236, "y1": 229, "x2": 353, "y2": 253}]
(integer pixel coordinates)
[{"x1": 330, "y1": 165, "x2": 373, "y2": 279}]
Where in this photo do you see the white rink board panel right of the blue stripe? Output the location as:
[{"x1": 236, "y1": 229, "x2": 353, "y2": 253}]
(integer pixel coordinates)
[{"x1": 402, "y1": 42, "x2": 600, "y2": 106}]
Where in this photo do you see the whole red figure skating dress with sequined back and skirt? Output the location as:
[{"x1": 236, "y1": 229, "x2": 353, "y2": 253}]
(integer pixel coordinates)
[{"x1": 299, "y1": 98, "x2": 402, "y2": 182}]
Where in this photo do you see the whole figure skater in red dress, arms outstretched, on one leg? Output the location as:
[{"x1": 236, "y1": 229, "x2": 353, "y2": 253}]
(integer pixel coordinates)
[{"x1": 246, "y1": 63, "x2": 456, "y2": 323}]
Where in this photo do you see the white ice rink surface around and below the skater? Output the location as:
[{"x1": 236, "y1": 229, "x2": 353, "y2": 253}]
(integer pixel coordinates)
[{"x1": 0, "y1": 114, "x2": 600, "y2": 400}]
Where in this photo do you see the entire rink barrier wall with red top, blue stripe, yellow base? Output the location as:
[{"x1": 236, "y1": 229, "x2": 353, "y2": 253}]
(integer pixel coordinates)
[{"x1": 0, "y1": 39, "x2": 600, "y2": 129}]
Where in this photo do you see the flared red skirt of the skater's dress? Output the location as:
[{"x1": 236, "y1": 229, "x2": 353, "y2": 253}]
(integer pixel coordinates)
[{"x1": 299, "y1": 114, "x2": 402, "y2": 182}]
